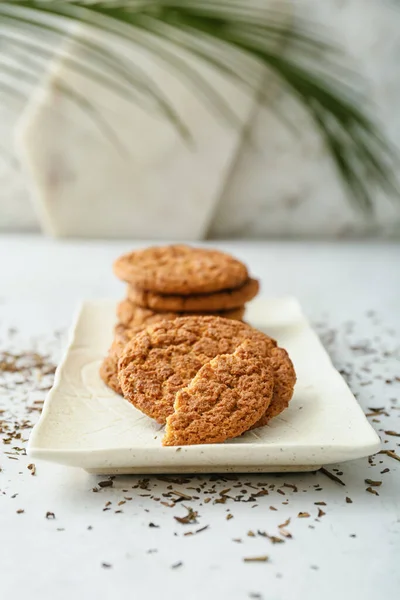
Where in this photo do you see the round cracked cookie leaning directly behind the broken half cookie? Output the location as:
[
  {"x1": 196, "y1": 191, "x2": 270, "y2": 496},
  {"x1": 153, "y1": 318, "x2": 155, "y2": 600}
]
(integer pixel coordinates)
[{"x1": 118, "y1": 316, "x2": 276, "y2": 423}]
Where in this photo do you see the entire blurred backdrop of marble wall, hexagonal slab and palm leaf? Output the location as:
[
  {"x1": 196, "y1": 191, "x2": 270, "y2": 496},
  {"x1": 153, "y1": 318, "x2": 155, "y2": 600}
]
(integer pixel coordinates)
[{"x1": 0, "y1": 0, "x2": 400, "y2": 240}]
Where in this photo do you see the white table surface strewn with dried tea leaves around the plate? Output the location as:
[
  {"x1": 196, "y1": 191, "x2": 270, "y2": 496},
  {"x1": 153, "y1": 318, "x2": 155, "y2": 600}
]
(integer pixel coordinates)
[{"x1": 0, "y1": 236, "x2": 400, "y2": 600}]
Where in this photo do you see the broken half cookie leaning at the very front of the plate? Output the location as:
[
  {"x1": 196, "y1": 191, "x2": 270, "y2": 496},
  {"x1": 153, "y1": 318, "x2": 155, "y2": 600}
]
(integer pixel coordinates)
[{"x1": 162, "y1": 342, "x2": 274, "y2": 446}]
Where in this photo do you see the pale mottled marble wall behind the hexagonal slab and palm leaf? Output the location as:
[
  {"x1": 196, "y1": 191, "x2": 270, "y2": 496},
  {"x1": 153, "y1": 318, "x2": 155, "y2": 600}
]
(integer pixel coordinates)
[{"x1": 0, "y1": 0, "x2": 400, "y2": 237}]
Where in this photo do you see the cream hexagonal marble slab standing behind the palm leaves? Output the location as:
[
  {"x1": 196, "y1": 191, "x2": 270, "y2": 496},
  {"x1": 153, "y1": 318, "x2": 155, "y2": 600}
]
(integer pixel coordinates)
[{"x1": 17, "y1": 29, "x2": 261, "y2": 239}]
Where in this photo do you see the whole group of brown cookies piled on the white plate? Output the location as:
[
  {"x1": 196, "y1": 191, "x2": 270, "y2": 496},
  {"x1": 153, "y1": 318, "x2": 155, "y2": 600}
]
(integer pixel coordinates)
[{"x1": 100, "y1": 245, "x2": 296, "y2": 446}]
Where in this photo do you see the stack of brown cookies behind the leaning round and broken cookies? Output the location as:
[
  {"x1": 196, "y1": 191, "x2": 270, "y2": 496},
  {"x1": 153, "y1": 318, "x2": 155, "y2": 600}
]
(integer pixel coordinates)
[{"x1": 100, "y1": 245, "x2": 259, "y2": 393}]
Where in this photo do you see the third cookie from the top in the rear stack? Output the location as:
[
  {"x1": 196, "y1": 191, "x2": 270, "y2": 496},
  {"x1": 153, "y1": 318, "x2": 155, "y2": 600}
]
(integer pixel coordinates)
[{"x1": 117, "y1": 300, "x2": 245, "y2": 329}]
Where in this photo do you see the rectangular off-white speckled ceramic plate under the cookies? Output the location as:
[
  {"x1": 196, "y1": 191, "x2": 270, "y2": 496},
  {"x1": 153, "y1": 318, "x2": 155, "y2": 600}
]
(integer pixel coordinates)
[{"x1": 28, "y1": 298, "x2": 380, "y2": 474}]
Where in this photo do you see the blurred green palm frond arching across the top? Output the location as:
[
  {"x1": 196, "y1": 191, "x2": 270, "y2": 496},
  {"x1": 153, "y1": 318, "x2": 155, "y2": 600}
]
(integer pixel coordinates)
[{"x1": 0, "y1": 0, "x2": 399, "y2": 212}]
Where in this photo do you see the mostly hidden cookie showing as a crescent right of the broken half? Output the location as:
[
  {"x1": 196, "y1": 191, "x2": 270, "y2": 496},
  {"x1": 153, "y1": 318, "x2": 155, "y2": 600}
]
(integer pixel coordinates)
[{"x1": 253, "y1": 348, "x2": 296, "y2": 428}]
